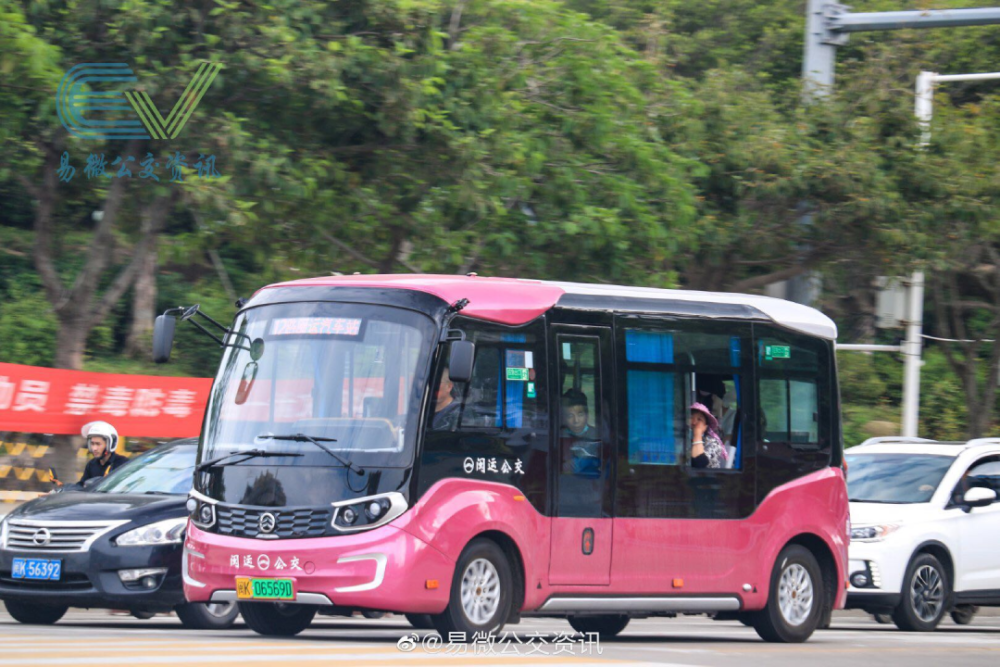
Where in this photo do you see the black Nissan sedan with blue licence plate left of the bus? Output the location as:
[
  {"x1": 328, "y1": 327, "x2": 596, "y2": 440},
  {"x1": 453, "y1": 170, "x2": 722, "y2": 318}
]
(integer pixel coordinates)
[{"x1": 0, "y1": 440, "x2": 239, "y2": 629}]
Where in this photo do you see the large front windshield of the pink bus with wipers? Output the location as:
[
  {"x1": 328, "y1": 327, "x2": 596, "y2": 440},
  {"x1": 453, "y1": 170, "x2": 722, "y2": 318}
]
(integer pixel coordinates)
[{"x1": 200, "y1": 302, "x2": 435, "y2": 467}]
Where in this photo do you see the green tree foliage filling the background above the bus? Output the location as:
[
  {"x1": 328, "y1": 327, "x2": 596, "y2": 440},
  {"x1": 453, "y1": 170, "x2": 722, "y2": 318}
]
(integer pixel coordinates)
[{"x1": 0, "y1": 0, "x2": 1000, "y2": 442}]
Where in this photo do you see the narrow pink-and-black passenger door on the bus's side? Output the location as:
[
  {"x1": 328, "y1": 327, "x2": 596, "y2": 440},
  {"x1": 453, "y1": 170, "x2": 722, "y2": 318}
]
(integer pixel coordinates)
[{"x1": 549, "y1": 325, "x2": 615, "y2": 585}]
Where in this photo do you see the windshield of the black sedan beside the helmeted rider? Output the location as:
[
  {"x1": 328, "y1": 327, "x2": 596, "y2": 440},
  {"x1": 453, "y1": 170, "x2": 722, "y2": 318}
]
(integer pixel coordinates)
[{"x1": 91, "y1": 445, "x2": 197, "y2": 495}]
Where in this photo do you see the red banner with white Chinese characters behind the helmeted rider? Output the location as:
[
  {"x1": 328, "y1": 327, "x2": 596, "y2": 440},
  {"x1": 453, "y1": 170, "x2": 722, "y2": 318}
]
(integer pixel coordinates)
[{"x1": 0, "y1": 364, "x2": 212, "y2": 438}]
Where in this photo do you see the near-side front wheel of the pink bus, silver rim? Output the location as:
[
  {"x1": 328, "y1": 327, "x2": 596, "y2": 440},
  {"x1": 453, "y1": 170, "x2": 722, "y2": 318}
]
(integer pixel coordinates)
[{"x1": 431, "y1": 538, "x2": 514, "y2": 641}]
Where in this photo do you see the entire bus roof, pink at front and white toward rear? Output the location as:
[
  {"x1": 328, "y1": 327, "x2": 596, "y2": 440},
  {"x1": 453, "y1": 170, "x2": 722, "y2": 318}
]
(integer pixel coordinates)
[{"x1": 267, "y1": 274, "x2": 837, "y2": 340}]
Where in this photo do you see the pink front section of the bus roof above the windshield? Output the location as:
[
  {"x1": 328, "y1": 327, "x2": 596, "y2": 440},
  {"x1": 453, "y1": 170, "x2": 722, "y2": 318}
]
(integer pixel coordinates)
[{"x1": 263, "y1": 274, "x2": 565, "y2": 325}]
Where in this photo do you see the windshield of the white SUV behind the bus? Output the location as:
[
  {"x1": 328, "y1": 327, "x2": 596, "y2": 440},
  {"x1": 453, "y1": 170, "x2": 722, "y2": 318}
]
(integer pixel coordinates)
[{"x1": 847, "y1": 454, "x2": 955, "y2": 504}]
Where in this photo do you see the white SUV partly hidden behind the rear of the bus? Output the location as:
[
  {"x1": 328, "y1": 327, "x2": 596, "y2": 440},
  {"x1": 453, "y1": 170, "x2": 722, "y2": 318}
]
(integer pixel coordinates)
[{"x1": 846, "y1": 438, "x2": 1000, "y2": 631}]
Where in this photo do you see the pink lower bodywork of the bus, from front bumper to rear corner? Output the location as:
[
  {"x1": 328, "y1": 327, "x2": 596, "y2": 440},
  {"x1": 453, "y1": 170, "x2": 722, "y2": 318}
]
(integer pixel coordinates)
[{"x1": 184, "y1": 468, "x2": 848, "y2": 613}]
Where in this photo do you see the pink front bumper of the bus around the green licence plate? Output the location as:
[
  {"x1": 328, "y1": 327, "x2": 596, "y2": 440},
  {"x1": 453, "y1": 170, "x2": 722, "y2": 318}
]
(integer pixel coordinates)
[{"x1": 182, "y1": 524, "x2": 455, "y2": 614}]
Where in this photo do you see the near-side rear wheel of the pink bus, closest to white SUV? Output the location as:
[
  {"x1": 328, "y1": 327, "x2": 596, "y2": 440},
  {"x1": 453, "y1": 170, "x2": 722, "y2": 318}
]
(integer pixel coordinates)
[{"x1": 753, "y1": 544, "x2": 823, "y2": 643}]
